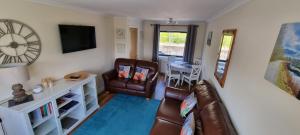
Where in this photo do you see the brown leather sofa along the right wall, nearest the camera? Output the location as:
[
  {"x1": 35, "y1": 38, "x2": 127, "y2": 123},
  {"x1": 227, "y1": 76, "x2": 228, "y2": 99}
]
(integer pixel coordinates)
[{"x1": 150, "y1": 81, "x2": 237, "y2": 135}]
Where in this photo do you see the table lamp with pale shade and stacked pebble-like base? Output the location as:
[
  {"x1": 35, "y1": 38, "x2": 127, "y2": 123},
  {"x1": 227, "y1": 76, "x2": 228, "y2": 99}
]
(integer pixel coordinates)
[{"x1": 0, "y1": 63, "x2": 29, "y2": 105}]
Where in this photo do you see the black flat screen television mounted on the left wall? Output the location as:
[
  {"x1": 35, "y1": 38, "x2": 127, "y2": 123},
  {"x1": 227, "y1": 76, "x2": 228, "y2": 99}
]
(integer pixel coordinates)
[{"x1": 59, "y1": 24, "x2": 96, "y2": 53}]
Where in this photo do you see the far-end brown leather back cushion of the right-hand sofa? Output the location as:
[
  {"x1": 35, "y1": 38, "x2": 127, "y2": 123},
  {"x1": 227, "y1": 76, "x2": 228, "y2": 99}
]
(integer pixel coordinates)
[{"x1": 193, "y1": 84, "x2": 217, "y2": 109}]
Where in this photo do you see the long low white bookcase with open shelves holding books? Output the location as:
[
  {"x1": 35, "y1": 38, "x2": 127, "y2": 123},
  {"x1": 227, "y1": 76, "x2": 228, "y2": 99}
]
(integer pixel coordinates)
[{"x1": 0, "y1": 74, "x2": 100, "y2": 135}]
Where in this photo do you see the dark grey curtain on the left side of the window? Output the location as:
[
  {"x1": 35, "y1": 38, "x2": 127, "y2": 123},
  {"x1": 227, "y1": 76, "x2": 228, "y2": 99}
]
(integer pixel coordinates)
[{"x1": 152, "y1": 24, "x2": 160, "y2": 62}]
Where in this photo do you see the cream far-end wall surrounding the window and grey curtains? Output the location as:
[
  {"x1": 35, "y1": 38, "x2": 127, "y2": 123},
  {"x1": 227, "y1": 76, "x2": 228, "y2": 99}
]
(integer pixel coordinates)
[{"x1": 143, "y1": 20, "x2": 206, "y2": 60}]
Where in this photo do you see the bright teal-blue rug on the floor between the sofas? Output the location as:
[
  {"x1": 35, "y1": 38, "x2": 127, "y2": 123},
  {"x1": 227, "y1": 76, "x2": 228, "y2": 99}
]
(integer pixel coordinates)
[{"x1": 73, "y1": 94, "x2": 160, "y2": 135}]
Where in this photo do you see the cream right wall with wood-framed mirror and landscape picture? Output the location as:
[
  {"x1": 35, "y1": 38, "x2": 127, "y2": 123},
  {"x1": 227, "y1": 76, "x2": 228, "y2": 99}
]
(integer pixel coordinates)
[{"x1": 203, "y1": 0, "x2": 300, "y2": 135}]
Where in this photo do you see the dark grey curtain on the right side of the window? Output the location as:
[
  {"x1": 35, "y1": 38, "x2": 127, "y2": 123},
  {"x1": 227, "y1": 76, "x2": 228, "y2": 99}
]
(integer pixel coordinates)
[{"x1": 183, "y1": 25, "x2": 198, "y2": 63}]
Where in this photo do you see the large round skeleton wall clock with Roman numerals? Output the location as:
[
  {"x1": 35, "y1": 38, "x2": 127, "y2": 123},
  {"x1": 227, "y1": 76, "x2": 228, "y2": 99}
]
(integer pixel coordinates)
[{"x1": 0, "y1": 19, "x2": 41, "y2": 65}]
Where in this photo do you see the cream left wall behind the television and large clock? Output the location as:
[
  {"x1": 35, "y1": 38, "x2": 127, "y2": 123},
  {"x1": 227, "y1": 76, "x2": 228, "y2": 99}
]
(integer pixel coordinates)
[{"x1": 0, "y1": 0, "x2": 114, "y2": 99}]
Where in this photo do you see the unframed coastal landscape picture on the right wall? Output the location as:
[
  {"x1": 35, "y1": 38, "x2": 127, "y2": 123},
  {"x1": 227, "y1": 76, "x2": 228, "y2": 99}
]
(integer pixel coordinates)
[{"x1": 265, "y1": 23, "x2": 300, "y2": 99}]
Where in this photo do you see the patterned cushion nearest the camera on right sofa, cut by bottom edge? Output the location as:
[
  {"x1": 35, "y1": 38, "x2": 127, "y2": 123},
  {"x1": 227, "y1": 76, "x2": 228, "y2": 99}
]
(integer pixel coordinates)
[{"x1": 180, "y1": 112, "x2": 195, "y2": 135}]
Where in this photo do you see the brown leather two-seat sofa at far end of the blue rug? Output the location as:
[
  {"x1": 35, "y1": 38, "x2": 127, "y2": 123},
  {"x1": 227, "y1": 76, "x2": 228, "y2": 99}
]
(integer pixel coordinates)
[{"x1": 102, "y1": 58, "x2": 158, "y2": 98}]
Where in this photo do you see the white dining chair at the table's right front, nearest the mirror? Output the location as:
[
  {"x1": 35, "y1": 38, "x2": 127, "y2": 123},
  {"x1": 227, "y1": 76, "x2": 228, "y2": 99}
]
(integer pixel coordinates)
[{"x1": 181, "y1": 64, "x2": 201, "y2": 90}]
